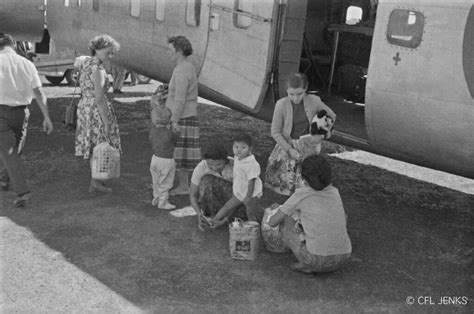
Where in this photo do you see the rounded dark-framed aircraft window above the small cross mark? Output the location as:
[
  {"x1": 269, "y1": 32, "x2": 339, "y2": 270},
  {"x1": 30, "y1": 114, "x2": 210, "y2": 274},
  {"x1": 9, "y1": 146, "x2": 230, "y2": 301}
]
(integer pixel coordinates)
[{"x1": 387, "y1": 9, "x2": 425, "y2": 49}]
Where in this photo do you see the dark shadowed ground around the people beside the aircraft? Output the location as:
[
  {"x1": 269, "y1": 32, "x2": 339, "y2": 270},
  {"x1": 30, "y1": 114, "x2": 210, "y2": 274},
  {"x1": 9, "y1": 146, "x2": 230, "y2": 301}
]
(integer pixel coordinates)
[{"x1": 0, "y1": 82, "x2": 474, "y2": 313}]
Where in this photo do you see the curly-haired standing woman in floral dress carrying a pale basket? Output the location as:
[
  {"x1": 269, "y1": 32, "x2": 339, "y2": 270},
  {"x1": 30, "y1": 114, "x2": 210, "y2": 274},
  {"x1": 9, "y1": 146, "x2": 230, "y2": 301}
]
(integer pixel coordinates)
[{"x1": 75, "y1": 35, "x2": 121, "y2": 193}]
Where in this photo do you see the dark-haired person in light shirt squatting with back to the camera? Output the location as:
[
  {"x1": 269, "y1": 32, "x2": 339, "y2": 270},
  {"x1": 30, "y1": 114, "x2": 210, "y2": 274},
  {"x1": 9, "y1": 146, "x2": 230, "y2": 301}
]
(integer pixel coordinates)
[{"x1": 268, "y1": 155, "x2": 352, "y2": 273}]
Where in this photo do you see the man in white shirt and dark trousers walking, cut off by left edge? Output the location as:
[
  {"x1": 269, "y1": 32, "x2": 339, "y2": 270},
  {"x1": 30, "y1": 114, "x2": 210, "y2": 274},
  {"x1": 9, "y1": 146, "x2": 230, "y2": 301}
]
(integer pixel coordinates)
[{"x1": 0, "y1": 33, "x2": 53, "y2": 207}]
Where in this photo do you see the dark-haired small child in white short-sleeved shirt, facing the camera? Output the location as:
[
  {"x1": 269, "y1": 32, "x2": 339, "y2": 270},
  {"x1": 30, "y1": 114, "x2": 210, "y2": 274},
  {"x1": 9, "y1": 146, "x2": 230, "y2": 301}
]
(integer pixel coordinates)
[{"x1": 212, "y1": 134, "x2": 262, "y2": 228}]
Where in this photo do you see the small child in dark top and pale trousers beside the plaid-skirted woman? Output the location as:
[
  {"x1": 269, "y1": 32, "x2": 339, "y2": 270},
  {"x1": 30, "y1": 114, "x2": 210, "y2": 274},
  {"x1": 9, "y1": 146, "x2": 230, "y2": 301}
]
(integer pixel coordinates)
[{"x1": 150, "y1": 106, "x2": 176, "y2": 209}]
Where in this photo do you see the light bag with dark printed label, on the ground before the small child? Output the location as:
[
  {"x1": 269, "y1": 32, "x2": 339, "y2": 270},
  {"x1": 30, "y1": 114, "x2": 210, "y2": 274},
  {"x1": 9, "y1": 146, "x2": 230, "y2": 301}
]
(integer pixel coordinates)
[{"x1": 229, "y1": 218, "x2": 260, "y2": 261}]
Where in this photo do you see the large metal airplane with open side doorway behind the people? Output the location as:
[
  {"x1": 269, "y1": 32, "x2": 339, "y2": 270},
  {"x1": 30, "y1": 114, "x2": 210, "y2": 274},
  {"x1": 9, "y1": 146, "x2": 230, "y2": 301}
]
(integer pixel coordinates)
[{"x1": 0, "y1": 0, "x2": 474, "y2": 179}]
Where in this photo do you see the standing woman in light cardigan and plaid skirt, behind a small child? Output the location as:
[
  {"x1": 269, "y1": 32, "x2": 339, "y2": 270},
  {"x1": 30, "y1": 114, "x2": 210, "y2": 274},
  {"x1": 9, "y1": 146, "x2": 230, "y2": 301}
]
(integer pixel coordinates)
[{"x1": 166, "y1": 36, "x2": 201, "y2": 195}]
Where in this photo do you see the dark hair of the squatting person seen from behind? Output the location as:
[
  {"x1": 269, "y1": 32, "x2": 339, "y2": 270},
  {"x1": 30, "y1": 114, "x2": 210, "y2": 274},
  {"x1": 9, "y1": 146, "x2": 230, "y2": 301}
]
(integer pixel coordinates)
[{"x1": 301, "y1": 155, "x2": 332, "y2": 190}]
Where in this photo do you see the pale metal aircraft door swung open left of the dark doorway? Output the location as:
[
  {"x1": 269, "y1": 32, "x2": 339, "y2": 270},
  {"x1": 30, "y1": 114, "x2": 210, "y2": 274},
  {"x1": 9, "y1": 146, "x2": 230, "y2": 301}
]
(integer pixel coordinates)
[{"x1": 199, "y1": 0, "x2": 274, "y2": 112}]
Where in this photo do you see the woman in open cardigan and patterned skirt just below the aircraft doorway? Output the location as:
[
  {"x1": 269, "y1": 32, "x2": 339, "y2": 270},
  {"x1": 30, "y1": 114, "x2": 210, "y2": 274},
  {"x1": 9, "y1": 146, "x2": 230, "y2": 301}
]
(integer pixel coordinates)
[{"x1": 265, "y1": 73, "x2": 336, "y2": 196}]
